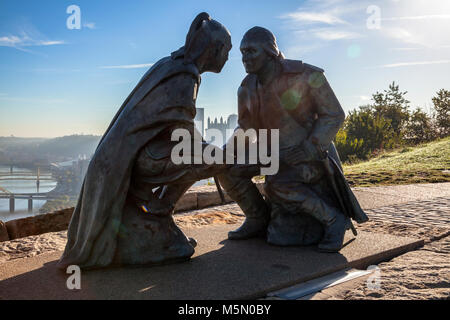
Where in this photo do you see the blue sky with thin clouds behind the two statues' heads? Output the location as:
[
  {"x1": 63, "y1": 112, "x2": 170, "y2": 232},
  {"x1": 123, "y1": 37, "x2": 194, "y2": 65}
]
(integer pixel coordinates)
[{"x1": 0, "y1": 0, "x2": 450, "y2": 137}]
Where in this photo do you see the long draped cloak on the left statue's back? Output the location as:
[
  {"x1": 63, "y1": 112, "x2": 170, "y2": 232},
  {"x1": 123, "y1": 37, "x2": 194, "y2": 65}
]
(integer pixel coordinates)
[{"x1": 58, "y1": 57, "x2": 201, "y2": 268}]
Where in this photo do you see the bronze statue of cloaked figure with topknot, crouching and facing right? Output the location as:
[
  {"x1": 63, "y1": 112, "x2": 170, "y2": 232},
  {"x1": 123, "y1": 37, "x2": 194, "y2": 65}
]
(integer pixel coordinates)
[{"x1": 58, "y1": 13, "x2": 231, "y2": 269}]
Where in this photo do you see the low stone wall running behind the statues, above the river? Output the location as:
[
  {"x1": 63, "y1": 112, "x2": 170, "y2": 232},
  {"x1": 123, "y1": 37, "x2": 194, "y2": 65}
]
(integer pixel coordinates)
[{"x1": 0, "y1": 183, "x2": 262, "y2": 242}]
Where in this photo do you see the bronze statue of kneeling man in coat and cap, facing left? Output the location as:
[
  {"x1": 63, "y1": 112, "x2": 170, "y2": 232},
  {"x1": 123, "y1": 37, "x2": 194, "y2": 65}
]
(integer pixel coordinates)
[{"x1": 219, "y1": 27, "x2": 368, "y2": 252}]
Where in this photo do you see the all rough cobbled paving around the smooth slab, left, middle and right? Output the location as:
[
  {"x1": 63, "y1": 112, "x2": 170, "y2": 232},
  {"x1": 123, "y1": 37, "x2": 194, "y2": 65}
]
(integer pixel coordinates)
[{"x1": 0, "y1": 183, "x2": 450, "y2": 299}]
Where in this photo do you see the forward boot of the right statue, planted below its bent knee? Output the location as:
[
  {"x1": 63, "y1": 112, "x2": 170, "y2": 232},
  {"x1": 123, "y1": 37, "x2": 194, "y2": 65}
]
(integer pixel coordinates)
[{"x1": 228, "y1": 184, "x2": 270, "y2": 240}]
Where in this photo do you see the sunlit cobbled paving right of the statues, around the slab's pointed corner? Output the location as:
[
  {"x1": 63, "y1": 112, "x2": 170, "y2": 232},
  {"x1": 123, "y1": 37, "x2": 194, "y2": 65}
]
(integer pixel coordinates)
[{"x1": 262, "y1": 183, "x2": 450, "y2": 300}]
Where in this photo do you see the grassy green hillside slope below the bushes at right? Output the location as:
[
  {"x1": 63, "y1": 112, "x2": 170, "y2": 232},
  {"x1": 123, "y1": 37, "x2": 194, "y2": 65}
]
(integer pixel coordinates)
[{"x1": 344, "y1": 137, "x2": 450, "y2": 186}]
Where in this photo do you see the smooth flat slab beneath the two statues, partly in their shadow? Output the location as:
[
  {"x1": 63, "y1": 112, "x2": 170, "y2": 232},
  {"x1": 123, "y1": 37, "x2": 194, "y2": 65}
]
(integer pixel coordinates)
[{"x1": 0, "y1": 224, "x2": 423, "y2": 300}]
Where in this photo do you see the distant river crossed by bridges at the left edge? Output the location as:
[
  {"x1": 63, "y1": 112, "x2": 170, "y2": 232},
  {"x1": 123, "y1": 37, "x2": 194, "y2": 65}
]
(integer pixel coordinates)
[{"x1": 0, "y1": 165, "x2": 56, "y2": 222}]
